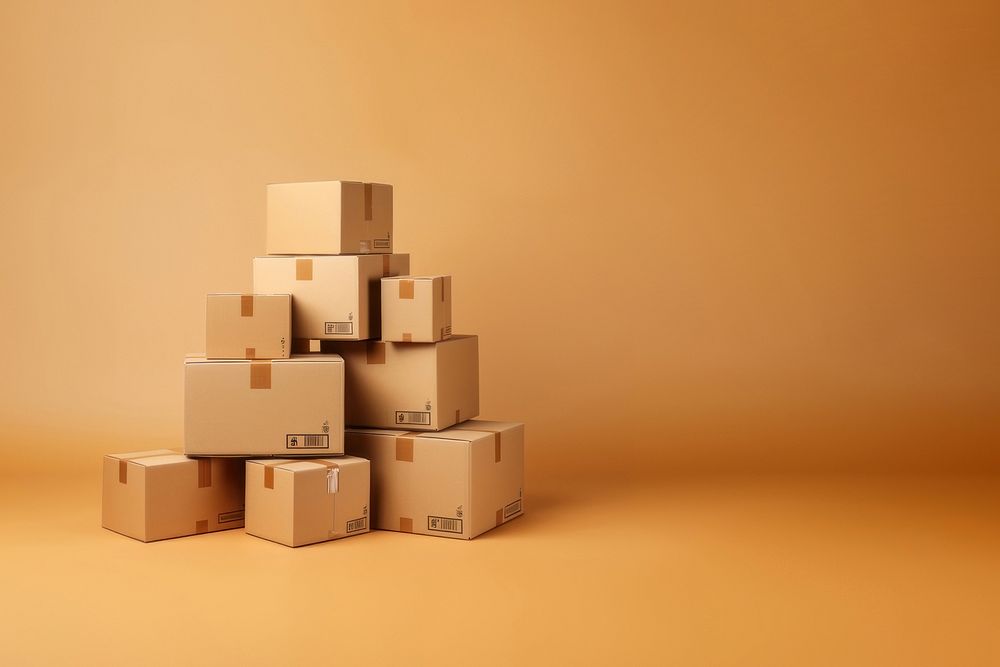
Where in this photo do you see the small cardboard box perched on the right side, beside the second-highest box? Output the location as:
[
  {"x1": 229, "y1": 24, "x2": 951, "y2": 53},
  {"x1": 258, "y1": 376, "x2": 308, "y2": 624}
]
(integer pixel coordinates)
[{"x1": 382, "y1": 276, "x2": 451, "y2": 343}]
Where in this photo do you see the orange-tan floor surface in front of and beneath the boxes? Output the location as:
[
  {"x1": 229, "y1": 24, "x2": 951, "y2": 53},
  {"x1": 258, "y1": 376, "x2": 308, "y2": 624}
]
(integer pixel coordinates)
[{"x1": 0, "y1": 476, "x2": 1000, "y2": 665}]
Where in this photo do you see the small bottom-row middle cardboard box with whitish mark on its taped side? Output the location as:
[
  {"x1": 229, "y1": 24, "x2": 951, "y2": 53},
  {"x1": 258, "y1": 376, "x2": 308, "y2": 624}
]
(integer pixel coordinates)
[{"x1": 246, "y1": 456, "x2": 371, "y2": 547}]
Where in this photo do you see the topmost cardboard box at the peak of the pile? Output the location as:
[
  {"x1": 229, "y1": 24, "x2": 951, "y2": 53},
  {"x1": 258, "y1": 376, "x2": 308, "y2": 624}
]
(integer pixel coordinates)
[{"x1": 267, "y1": 181, "x2": 392, "y2": 255}]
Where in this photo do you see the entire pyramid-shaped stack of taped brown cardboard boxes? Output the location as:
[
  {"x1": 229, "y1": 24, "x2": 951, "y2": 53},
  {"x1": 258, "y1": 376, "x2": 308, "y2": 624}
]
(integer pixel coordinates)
[{"x1": 103, "y1": 181, "x2": 524, "y2": 546}]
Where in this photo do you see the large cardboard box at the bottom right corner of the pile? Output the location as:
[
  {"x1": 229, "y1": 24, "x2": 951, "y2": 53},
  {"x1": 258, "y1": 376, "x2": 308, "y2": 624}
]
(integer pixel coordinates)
[{"x1": 344, "y1": 420, "x2": 524, "y2": 539}]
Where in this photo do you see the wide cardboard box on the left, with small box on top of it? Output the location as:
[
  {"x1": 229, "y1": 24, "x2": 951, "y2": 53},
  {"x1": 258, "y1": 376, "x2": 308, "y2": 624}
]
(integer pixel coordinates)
[{"x1": 184, "y1": 354, "x2": 344, "y2": 456}]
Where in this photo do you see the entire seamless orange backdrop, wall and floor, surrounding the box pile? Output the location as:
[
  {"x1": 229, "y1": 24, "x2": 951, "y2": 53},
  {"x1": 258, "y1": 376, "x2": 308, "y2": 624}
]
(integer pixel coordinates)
[{"x1": 0, "y1": 0, "x2": 1000, "y2": 664}]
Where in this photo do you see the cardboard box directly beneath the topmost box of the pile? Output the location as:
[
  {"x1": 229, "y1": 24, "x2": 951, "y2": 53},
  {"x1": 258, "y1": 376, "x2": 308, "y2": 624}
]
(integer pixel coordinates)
[{"x1": 253, "y1": 255, "x2": 410, "y2": 340}]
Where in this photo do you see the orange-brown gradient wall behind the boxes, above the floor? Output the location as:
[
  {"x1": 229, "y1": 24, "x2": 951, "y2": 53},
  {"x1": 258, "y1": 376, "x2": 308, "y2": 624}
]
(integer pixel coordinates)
[{"x1": 0, "y1": 2, "x2": 1000, "y2": 474}]
